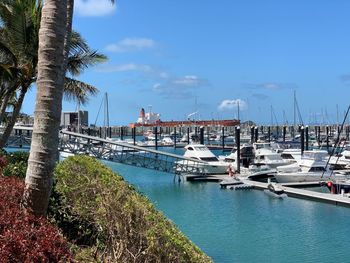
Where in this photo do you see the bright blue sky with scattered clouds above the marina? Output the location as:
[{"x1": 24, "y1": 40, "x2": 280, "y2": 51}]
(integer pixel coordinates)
[{"x1": 23, "y1": 0, "x2": 350, "y2": 125}]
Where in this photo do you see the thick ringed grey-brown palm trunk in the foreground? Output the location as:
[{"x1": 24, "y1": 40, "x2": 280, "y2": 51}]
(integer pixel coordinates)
[{"x1": 23, "y1": 0, "x2": 67, "y2": 215}]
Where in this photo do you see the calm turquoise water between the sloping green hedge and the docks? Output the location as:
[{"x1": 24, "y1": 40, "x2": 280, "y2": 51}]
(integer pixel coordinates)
[{"x1": 106, "y1": 149, "x2": 350, "y2": 262}]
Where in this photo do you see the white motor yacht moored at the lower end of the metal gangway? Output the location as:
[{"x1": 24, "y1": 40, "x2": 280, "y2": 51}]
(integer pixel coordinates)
[{"x1": 179, "y1": 144, "x2": 230, "y2": 175}]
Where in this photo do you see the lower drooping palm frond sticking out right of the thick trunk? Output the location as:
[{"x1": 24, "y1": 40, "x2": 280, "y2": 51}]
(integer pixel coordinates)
[{"x1": 63, "y1": 77, "x2": 99, "y2": 105}]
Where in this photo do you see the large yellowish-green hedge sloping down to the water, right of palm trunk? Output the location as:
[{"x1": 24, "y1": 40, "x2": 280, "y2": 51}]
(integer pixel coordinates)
[{"x1": 55, "y1": 156, "x2": 211, "y2": 262}]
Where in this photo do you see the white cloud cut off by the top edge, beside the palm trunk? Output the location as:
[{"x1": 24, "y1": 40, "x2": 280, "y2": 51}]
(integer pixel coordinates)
[{"x1": 74, "y1": 0, "x2": 116, "y2": 16}]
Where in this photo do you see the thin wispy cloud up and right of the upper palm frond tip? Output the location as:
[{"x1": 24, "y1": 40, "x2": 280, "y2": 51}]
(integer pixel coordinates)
[{"x1": 105, "y1": 38, "x2": 156, "y2": 53}]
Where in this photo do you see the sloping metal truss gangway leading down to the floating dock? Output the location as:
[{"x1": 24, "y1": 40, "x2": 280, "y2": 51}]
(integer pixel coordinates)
[{"x1": 59, "y1": 131, "x2": 208, "y2": 175}]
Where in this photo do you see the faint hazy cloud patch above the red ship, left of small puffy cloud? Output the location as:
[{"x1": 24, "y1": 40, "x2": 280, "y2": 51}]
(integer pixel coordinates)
[{"x1": 153, "y1": 75, "x2": 209, "y2": 99}]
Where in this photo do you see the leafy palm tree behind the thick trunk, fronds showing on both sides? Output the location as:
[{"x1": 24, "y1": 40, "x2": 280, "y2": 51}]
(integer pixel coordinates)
[{"x1": 0, "y1": 0, "x2": 106, "y2": 148}]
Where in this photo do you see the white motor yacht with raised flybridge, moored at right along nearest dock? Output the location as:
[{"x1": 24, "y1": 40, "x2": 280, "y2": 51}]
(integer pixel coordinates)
[{"x1": 275, "y1": 150, "x2": 346, "y2": 183}]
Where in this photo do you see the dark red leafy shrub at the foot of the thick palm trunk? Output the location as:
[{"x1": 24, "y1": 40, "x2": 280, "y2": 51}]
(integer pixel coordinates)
[{"x1": 0, "y1": 176, "x2": 73, "y2": 263}]
